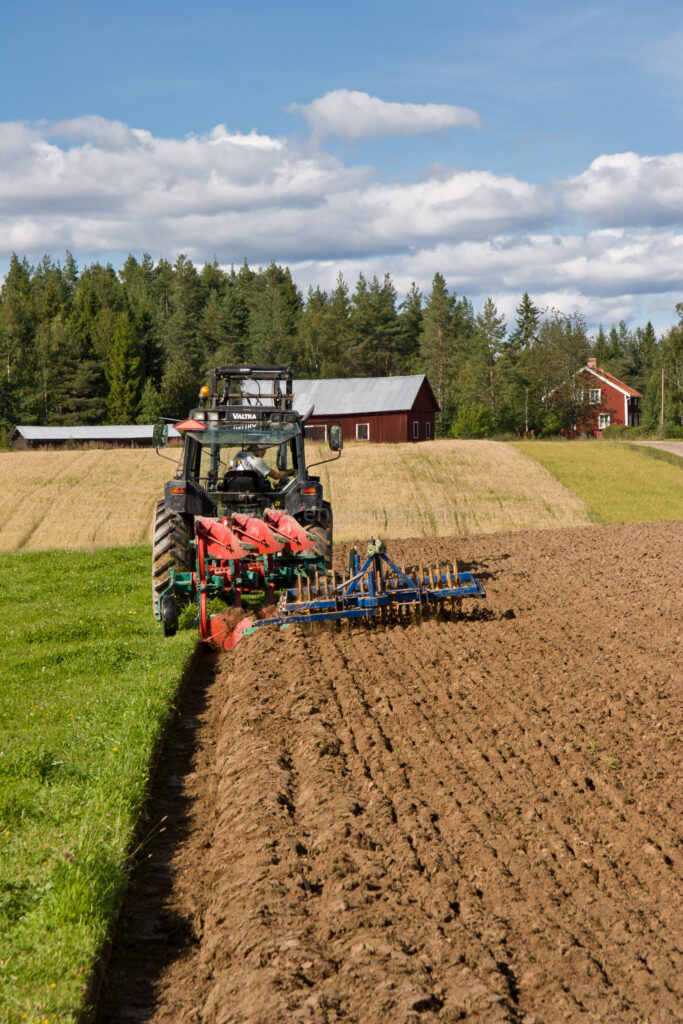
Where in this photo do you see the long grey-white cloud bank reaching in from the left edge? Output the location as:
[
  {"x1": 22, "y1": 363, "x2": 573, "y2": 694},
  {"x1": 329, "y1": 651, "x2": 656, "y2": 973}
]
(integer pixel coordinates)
[{"x1": 0, "y1": 118, "x2": 556, "y2": 261}]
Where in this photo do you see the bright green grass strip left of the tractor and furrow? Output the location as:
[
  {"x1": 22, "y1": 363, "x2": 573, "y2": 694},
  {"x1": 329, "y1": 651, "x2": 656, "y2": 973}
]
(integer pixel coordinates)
[{"x1": 0, "y1": 547, "x2": 196, "y2": 1024}]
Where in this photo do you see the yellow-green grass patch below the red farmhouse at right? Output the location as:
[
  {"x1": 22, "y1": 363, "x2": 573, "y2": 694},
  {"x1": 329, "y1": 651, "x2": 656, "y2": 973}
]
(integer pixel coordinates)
[{"x1": 515, "y1": 440, "x2": 683, "y2": 523}]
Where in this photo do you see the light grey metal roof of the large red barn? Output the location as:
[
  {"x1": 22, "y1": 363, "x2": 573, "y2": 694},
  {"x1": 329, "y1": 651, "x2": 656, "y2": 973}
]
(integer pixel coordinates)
[{"x1": 292, "y1": 374, "x2": 438, "y2": 416}]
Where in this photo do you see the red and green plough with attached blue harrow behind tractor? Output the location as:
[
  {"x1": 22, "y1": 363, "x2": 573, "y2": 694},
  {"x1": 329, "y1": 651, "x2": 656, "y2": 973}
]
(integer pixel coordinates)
[{"x1": 160, "y1": 509, "x2": 485, "y2": 650}]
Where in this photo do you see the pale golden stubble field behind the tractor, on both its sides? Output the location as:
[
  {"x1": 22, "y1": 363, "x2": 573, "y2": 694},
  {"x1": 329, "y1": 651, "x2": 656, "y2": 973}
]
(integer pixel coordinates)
[{"x1": 0, "y1": 440, "x2": 590, "y2": 551}]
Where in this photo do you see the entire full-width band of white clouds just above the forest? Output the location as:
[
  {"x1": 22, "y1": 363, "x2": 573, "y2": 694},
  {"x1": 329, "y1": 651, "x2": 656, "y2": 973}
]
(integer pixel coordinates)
[{"x1": 0, "y1": 116, "x2": 683, "y2": 318}]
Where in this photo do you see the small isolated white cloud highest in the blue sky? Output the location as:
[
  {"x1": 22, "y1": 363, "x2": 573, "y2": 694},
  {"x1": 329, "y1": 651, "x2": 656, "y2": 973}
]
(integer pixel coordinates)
[{"x1": 286, "y1": 89, "x2": 480, "y2": 142}]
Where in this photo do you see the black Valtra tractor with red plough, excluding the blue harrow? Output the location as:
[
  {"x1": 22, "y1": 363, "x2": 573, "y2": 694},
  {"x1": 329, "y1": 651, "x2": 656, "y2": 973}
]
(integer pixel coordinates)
[{"x1": 152, "y1": 367, "x2": 343, "y2": 647}]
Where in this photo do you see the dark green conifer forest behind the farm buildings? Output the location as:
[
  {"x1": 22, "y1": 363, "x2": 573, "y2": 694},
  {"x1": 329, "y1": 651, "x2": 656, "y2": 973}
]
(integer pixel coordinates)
[{"x1": 0, "y1": 252, "x2": 683, "y2": 443}]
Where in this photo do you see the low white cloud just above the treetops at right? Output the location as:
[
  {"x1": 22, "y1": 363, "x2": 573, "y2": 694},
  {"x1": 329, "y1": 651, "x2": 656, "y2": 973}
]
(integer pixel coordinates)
[{"x1": 290, "y1": 228, "x2": 683, "y2": 325}]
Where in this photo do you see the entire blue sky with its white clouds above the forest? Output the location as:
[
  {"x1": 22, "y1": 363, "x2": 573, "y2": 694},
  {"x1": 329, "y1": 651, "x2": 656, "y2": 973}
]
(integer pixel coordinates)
[{"x1": 0, "y1": 0, "x2": 683, "y2": 329}]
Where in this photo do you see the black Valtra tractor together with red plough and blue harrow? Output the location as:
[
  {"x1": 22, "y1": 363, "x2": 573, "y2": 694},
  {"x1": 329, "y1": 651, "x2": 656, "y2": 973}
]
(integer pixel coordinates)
[{"x1": 152, "y1": 367, "x2": 484, "y2": 650}]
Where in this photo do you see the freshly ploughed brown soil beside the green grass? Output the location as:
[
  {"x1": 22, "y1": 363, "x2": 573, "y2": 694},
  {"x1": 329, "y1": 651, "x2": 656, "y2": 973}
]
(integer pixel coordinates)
[{"x1": 96, "y1": 522, "x2": 683, "y2": 1024}]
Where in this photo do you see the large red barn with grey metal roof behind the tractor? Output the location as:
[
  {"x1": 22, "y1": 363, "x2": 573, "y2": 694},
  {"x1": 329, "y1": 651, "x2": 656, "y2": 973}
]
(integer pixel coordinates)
[{"x1": 292, "y1": 374, "x2": 439, "y2": 444}]
